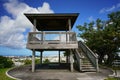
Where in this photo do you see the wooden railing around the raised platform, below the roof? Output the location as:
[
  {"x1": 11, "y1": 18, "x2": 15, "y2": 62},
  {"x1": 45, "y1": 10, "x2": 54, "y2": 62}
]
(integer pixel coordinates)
[{"x1": 28, "y1": 32, "x2": 77, "y2": 44}]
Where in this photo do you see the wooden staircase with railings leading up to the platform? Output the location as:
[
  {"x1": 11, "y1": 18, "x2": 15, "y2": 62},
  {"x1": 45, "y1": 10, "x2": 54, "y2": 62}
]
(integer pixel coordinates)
[{"x1": 73, "y1": 43, "x2": 98, "y2": 72}]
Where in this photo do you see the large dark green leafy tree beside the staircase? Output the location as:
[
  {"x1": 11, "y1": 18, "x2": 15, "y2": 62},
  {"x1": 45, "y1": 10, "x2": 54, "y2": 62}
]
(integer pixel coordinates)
[{"x1": 77, "y1": 11, "x2": 120, "y2": 65}]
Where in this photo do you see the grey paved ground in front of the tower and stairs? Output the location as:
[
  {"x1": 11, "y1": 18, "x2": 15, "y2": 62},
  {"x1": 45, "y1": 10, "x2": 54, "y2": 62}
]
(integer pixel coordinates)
[{"x1": 8, "y1": 66, "x2": 112, "y2": 80}]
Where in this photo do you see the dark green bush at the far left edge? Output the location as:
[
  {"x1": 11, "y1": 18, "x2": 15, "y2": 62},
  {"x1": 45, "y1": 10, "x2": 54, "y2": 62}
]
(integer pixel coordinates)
[{"x1": 0, "y1": 56, "x2": 13, "y2": 68}]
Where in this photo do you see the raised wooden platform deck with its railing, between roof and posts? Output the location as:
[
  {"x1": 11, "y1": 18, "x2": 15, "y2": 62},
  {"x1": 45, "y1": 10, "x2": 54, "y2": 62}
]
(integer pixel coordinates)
[{"x1": 27, "y1": 32, "x2": 78, "y2": 50}]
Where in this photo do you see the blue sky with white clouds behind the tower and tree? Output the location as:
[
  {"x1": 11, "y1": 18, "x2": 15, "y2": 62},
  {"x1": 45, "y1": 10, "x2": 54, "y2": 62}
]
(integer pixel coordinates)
[{"x1": 0, "y1": 0, "x2": 120, "y2": 55}]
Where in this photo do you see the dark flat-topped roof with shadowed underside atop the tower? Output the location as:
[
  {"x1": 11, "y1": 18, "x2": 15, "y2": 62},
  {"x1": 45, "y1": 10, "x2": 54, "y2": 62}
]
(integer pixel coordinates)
[{"x1": 24, "y1": 13, "x2": 79, "y2": 31}]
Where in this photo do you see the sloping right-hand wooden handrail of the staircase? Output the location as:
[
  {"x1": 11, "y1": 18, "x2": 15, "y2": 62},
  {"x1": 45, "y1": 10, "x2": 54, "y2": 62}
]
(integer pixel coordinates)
[{"x1": 78, "y1": 41, "x2": 99, "y2": 71}]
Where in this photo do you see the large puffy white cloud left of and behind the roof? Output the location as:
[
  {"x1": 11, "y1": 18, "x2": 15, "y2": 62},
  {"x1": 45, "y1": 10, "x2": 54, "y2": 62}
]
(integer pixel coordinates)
[{"x1": 0, "y1": 0, "x2": 54, "y2": 48}]
